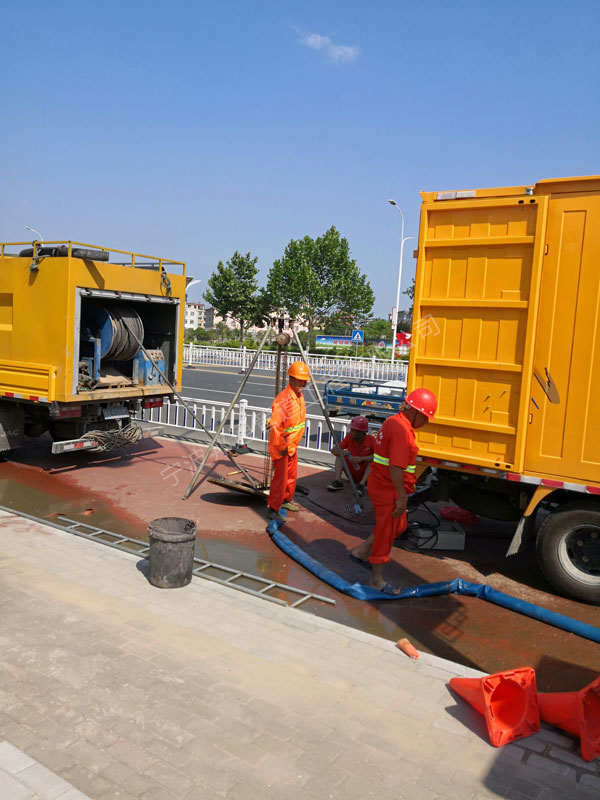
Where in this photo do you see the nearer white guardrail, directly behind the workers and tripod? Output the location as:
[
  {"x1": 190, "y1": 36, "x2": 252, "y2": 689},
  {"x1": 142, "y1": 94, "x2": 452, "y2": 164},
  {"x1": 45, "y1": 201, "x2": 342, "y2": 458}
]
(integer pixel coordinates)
[{"x1": 140, "y1": 397, "x2": 366, "y2": 453}]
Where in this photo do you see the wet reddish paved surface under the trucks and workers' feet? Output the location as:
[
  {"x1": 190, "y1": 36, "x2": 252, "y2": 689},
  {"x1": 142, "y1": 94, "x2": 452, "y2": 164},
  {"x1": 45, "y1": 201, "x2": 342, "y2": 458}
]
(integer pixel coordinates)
[{"x1": 0, "y1": 439, "x2": 600, "y2": 691}]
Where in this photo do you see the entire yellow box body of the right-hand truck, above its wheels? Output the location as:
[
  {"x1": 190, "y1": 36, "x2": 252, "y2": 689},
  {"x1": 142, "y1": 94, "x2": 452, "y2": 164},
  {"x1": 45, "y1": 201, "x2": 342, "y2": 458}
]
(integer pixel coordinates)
[{"x1": 408, "y1": 177, "x2": 600, "y2": 485}]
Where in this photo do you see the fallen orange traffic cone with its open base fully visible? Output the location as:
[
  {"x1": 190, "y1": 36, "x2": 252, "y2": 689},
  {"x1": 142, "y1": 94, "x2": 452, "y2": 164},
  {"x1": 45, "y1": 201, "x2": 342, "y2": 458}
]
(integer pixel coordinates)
[{"x1": 450, "y1": 667, "x2": 540, "y2": 747}]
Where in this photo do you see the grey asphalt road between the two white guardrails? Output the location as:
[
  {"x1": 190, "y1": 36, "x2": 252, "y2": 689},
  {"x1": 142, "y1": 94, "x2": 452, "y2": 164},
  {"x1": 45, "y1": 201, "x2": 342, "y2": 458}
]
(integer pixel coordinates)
[{"x1": 182, "y1": 366, "x2": 325, "y2": 416}]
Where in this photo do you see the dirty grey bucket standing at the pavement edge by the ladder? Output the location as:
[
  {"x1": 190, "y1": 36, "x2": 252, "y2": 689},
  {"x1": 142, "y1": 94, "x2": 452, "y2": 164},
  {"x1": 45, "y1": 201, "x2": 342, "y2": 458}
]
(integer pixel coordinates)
[{"x1": 148, "y1": 517, "x2": 198, "y2": 589}]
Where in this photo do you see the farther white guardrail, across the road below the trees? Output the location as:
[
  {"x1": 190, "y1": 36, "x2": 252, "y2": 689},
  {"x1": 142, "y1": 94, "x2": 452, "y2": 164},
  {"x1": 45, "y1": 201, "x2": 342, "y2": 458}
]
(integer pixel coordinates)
[{"x1": 183, "y1": 344, "x2": 408, "y2": 382}]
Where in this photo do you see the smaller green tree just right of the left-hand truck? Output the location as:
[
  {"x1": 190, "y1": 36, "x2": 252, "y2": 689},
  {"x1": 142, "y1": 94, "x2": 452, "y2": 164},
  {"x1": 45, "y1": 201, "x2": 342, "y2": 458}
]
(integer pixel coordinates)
[{"x1": 204, "y1": 250, "x2": 261, "y2": 347}]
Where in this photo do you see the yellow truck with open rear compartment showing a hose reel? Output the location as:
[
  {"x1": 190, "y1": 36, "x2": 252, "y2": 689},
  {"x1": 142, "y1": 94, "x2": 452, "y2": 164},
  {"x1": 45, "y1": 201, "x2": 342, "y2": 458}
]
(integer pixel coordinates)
[{"x1": 0, "y1": 241, "x2": 186, "y2": 453}]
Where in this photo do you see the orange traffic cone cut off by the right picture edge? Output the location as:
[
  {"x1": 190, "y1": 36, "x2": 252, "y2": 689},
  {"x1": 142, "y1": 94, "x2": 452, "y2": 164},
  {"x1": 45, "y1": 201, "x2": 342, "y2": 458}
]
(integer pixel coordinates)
[{"x1": 538, "y1": 678, "x2": 600, "y2": 761}]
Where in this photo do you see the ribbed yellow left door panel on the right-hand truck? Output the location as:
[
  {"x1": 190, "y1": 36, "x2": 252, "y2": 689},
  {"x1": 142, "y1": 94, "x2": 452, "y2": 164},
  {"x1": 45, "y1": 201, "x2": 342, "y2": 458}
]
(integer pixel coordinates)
[{"x1": 409, "y1": 187, "x2": 548, "y2": 472}]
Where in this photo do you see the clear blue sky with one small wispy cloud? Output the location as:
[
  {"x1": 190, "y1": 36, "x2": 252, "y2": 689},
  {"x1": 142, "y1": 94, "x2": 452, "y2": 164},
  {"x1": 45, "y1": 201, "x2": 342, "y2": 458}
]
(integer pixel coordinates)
[{"x1": 0, "y1": 0, "x2": 600, "y2": 316}]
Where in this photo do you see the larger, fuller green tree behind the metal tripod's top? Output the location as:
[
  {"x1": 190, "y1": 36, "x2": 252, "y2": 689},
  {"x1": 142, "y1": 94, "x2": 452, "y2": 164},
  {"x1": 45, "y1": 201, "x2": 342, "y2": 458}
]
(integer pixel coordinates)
[{"x1": 266, "y1": 227, "x2": 375, "y2": 350}]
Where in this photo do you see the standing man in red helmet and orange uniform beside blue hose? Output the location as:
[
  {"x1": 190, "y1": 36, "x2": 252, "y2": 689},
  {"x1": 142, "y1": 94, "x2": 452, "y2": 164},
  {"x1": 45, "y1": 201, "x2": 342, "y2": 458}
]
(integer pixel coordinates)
[{"x1": 350, "y1": 389, "x2": 437, "y2": 594}]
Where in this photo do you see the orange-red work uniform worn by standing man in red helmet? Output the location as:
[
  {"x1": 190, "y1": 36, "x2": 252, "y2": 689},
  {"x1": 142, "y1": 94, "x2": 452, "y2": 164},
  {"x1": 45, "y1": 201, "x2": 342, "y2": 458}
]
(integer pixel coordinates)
[{"x1": 368, "y1": 413, "x2": 419, "y2": 564}]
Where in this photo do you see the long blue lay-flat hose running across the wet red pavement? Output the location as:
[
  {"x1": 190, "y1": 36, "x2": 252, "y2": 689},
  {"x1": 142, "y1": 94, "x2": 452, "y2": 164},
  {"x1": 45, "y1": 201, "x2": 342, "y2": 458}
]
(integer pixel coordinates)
[{"x1": 268, "y1": 523, "x2": 600, "y2": 644}]
